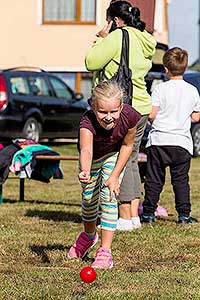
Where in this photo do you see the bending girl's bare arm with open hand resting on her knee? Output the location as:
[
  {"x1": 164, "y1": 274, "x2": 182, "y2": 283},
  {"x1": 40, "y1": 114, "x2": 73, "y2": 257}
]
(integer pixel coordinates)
[{"x1": 105, "y1": 127, "x2": 136, "y2": 198}]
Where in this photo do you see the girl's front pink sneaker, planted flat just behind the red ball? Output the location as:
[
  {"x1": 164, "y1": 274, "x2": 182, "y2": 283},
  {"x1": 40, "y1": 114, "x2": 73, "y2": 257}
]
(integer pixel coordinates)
[{"x1": 92, "y1": 247, "x2": 113, "y2": 269}]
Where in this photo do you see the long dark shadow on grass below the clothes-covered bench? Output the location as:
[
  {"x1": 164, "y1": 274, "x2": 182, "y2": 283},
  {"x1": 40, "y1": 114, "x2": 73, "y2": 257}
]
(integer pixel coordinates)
[{"x1": 25, "y1": 209, "x2": 82, "y2": 223}]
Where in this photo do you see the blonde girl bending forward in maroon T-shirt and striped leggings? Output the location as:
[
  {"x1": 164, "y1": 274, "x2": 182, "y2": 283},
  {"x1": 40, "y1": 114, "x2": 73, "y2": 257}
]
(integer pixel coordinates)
[{"x1": 68, "y1": 81, "x2": 140, "y2": 269}]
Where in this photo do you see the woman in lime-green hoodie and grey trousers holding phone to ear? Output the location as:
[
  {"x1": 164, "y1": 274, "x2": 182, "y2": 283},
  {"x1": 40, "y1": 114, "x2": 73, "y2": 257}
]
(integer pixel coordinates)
[{"x1": 85, "y1": 1, "x2": 156, "y2": 230}]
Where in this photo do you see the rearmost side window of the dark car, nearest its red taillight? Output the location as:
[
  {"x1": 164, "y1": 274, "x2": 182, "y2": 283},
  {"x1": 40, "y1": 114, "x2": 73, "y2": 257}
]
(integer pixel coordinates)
[{"x1": 10, "y1": 76, "x2": 30, "y2": 95}]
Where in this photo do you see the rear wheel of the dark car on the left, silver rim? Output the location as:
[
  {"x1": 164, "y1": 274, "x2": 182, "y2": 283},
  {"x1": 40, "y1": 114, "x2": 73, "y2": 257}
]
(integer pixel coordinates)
[{"x1": 23, "y1": 118, "x2": 42, "y2": 142}]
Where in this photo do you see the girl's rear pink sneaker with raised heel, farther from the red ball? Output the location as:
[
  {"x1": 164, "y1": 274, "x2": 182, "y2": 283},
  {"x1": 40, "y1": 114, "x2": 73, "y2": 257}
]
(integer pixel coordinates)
[{"x1": 68, "y1": 232, "x2": 98, "y2": 258}]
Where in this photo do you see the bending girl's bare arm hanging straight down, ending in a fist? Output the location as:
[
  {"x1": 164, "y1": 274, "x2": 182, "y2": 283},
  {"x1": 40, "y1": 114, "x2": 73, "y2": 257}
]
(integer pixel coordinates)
[{"x1": 78, "y1": 128, "x2": 93, "y2": 183}]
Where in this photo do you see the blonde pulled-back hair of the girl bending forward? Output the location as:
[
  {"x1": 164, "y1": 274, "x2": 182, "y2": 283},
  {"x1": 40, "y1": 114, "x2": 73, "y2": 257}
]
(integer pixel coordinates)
[{"x1": 90, "y1": 80, "x2": 124, "y2": 110}]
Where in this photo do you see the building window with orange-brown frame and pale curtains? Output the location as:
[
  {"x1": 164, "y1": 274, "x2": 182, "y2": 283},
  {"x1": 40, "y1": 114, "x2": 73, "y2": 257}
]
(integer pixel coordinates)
[{"x1": 42, "y1": 0, "x2": 96, "y2": 24}]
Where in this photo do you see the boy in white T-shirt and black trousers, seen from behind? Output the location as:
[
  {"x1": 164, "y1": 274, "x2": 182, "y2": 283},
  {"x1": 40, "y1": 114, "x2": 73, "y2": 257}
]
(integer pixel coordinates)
[{"x1": 142, "y1": 47, "x2": 200, "y2": 224}]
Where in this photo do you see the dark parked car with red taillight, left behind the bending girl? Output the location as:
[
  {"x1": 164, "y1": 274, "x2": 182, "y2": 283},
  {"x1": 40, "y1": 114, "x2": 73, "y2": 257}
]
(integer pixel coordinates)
[{"x1": 0, "y1": 68, "x2": 88, "y2": 141}]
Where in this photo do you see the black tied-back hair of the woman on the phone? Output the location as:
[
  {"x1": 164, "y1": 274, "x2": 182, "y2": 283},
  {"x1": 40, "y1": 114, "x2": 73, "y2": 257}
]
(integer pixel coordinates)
[{"x1": 106, "y1": 1, "x2": 146, "y2": 31}]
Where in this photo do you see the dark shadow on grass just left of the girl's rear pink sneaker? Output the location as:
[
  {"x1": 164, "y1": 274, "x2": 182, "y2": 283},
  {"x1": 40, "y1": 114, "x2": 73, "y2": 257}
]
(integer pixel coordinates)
[{"x1": 29, "y1": 244, "x2": 70, "y2": 264}]
